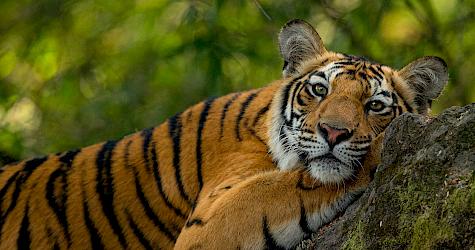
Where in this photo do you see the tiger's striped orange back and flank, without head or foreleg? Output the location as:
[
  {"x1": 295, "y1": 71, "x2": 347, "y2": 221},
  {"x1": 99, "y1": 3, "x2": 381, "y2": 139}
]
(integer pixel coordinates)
[{"x1": 0, "y1": 85, "x2": 276, "y2": 248}]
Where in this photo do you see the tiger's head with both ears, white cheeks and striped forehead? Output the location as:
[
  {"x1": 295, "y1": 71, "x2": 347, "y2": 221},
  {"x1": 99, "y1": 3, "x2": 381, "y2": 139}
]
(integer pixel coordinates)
[{"x1": 269, "y1": 20, "x2": 448, "y2": 184}]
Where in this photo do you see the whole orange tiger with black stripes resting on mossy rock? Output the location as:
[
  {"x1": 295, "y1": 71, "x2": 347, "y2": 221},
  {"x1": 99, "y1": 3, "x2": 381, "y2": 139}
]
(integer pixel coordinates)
[{"x1": 0, "y1": 19, "x2": 448, "y2": 249}]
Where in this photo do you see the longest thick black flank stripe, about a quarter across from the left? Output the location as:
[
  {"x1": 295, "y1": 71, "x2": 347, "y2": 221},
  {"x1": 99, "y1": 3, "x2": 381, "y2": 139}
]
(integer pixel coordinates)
[{"x1": 96, "y1": 141, "x2": 127, "y2": 248}]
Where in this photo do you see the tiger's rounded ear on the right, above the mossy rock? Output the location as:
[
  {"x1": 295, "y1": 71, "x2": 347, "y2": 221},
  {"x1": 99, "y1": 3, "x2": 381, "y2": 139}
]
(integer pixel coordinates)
[{"x1": 399, "y1": 56, "x2": 449, "y2": 114}]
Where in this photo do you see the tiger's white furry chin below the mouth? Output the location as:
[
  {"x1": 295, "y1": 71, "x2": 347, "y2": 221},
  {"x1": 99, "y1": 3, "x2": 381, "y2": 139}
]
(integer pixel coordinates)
[{"x1": 305, "y1": 154, "x2": 354, "y2": 185}]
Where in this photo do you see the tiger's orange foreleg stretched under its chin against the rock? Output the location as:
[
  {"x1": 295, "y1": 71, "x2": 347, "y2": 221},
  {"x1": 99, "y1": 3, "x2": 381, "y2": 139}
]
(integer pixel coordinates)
[{"x1": 175, "y1": 170, "x2": 369, "y2": 249}]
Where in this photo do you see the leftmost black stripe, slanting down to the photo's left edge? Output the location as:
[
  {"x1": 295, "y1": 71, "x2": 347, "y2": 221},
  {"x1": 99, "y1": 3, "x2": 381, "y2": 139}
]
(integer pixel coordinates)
[{"x1": 0, "y1": 157, "x2": 48, "y2": 232}]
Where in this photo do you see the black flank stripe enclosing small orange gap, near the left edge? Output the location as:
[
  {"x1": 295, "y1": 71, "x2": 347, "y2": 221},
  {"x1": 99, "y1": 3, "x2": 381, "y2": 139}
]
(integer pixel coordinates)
[{"x1": 45, "y1": 150, "x2": 80, "y2": 246}]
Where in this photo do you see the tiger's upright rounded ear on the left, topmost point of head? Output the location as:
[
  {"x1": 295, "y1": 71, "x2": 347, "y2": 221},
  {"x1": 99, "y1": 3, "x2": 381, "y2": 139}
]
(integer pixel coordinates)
[{"x1": 279, "y1": 19, "x2": 326, "y2": 77}]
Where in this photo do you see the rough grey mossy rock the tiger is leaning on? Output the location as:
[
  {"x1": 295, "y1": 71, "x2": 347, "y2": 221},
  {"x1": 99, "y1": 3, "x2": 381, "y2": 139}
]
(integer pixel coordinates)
[{"x1": 299, "y1": 104, "x2": 475, "y2": 249}]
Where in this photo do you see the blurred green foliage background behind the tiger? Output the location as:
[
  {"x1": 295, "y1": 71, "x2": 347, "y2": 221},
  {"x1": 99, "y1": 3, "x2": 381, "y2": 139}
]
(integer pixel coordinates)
[{"x1": 0, "y1": 0, "x2": 475, "y2": 164}]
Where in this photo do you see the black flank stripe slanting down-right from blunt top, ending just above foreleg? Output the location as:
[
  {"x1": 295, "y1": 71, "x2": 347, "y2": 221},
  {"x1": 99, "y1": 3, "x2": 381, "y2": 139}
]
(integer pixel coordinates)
[{"x1": 168, "y1": 113, "x2": 194, "y2": 206}]
